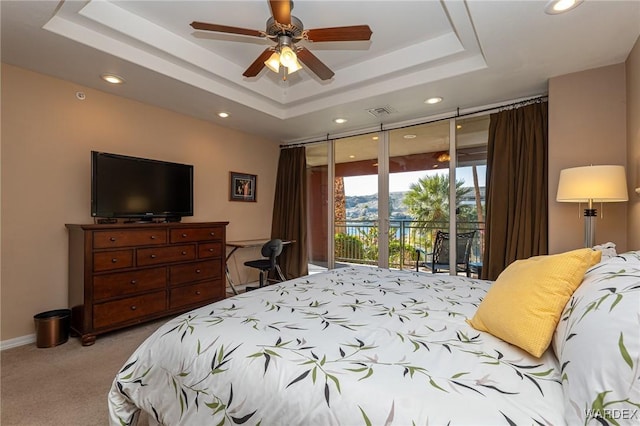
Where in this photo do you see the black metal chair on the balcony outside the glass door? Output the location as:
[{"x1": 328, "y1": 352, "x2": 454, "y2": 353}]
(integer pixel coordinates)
[{"x1": 416, "y1": 231, "x2": 476, "y2": 277}]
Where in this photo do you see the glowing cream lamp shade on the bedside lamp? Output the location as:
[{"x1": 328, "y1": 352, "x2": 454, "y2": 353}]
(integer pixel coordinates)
[{"x1": 556, "y1": 166, "x2": 629, "y2": 203}]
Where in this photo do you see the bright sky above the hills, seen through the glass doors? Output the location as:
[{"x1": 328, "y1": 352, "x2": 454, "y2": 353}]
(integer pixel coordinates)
[{"x1": 344, "y1": 166, "x2": 487, "y2": 196}]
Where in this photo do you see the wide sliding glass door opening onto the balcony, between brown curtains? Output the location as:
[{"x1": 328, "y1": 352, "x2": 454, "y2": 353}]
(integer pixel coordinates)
[{"x1": 307, "y1": 116, "x2": 488, "y2": 270}]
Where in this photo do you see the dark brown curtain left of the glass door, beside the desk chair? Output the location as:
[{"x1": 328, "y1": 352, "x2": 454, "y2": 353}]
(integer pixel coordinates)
[{"x1": 271, "y1": 147, "x2": 309, "y2": 279}]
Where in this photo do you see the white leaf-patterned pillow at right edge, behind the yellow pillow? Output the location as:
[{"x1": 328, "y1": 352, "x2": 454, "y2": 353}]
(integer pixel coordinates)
[{"x1": 553, "y1": 251, "x2": 640, "y2": 425}]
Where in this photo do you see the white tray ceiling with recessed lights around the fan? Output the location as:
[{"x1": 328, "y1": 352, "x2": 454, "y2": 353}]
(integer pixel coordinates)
[{"x1": 1, "y1": 0, "x2": 640, "y2": 142}]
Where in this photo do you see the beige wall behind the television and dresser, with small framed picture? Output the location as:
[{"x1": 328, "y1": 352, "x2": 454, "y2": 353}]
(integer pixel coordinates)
[{"x1": 0, "y1": 64, "x2": 279, "y2": 342}]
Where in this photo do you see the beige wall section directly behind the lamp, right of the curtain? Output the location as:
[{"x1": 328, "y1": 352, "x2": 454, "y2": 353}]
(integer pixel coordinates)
[{"x1": 549, "y1": 63, "x2": 628, "y2": 253}]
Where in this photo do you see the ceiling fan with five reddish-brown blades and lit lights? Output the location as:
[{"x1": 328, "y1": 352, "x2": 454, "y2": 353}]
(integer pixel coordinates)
[{"x1": 191, "y1": 0, "x2": 372, "y2": 80}]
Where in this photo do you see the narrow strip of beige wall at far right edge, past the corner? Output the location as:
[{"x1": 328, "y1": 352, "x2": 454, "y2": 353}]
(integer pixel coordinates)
[{"x1": 626, "y1": 37, "x2": 640, "y2": 249}]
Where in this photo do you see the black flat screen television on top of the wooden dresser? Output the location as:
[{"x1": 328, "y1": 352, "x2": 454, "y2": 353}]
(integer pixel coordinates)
[{"x1": 91, "y1": 151, "x2": 193, "y2": 221}]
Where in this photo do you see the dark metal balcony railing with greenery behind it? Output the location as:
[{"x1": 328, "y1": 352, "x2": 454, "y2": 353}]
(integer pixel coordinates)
[{"x1": 335, "y1": 220, "x2": 484, "y2": 269}]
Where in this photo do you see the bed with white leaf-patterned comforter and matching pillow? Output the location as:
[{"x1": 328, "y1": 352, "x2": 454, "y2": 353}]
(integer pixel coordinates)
[{"x1": 108, "y1": 248, "x2": 640, "y2": 425}]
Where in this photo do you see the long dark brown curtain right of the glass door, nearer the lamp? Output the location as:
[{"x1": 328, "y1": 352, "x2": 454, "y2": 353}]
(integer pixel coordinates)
[{"x1": 482, "y1": 102, "x2": 548, "y2": 280}]
